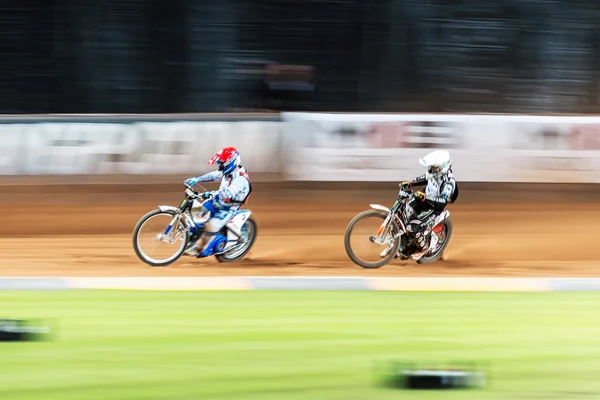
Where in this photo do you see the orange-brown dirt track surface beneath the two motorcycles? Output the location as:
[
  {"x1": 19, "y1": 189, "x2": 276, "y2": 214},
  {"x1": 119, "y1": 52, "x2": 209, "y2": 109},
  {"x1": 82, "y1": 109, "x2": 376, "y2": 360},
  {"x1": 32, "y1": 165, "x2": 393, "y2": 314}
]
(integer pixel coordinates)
[{"x1": 0, "y1": 183, "x2": 600, "y2": 277}]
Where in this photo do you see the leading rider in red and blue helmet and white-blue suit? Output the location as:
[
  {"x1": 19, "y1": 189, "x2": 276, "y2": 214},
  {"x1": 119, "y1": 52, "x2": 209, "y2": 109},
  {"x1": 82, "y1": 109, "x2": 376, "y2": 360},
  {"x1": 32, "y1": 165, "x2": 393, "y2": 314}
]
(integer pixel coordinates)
[{"x1": 185, "y1": 147, "x2": 252, "y2": 257}]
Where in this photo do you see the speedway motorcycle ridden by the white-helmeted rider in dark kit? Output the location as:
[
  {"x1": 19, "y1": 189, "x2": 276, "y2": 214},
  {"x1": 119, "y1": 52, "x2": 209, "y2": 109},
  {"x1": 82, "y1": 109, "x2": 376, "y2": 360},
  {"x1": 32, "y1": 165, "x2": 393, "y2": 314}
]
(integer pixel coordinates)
[{"x1": 344, "y1": 188, "x2": 452, "y2": 268}]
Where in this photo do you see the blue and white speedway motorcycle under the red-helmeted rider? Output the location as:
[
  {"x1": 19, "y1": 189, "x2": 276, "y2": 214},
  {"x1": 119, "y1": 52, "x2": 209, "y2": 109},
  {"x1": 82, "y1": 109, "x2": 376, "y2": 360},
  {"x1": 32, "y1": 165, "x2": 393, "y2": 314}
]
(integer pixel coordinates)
[{"x1": 133, "y1": 184, "x2": 257, "y2": 267}]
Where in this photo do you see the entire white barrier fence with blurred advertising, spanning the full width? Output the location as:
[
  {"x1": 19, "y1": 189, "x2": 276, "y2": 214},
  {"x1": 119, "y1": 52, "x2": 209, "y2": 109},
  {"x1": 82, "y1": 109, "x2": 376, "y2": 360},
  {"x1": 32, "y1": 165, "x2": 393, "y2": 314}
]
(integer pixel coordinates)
[{"x1": 0, "y1": 113, "x2": 600, "y2": 183}]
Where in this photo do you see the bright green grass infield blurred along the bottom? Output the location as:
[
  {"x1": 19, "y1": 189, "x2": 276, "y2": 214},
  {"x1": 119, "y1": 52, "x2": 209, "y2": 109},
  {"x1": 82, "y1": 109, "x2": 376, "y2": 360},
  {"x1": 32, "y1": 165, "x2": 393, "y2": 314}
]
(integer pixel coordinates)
[{"x1": 0, "y1": 291, "x2": 600, "y2": 400}]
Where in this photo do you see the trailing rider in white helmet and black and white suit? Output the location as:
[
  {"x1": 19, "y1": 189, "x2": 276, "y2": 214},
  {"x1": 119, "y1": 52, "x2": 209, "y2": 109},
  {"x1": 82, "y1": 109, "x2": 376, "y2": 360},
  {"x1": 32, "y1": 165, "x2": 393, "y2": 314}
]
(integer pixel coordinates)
[{"x1": 400, "y1": 150, "x2": 458, "y2": 260}]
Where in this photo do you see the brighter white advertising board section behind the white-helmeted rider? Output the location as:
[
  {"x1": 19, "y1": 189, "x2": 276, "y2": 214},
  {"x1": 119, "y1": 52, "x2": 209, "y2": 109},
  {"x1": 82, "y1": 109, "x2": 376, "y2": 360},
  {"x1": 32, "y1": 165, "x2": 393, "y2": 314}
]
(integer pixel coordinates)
[{"x1": 282, "y1": 113, "x2": 600, "y2": 183}]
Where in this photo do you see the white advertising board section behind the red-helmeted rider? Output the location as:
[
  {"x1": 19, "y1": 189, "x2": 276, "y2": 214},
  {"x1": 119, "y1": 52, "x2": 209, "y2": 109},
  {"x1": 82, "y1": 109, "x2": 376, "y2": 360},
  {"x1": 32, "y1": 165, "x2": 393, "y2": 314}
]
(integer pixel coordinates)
[{"x1": 0, "y1": 121, "x2": 281, "y2": 175}]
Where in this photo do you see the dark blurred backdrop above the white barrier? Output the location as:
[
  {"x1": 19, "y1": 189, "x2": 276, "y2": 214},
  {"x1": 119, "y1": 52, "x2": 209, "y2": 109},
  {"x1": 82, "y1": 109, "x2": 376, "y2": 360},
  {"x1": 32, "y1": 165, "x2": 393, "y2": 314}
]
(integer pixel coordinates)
[{"x1": 0, "y1": 0, "x2": 600, "y2": 114}]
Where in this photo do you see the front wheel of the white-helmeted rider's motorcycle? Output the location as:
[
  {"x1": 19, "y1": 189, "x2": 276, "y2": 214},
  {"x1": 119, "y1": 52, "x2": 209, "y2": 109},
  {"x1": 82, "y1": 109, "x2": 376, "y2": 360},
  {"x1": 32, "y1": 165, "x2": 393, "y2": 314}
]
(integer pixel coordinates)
[{"x1": 344, "y1": 210, "x2": 400, "y2": 268}]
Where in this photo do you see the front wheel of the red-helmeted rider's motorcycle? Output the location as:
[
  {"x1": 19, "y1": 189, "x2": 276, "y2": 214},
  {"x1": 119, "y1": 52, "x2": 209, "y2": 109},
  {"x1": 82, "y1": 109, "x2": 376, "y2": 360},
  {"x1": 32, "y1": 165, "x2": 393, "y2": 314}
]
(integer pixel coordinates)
[{"x1": 133, "y1": 210, "x2": 188, "y2": 267}]
